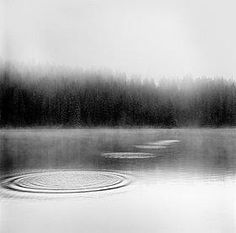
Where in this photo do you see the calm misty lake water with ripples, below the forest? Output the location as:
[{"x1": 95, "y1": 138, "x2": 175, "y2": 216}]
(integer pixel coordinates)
[{"x1": 0, "y1": 129, "x2": 236, "y2": 233}]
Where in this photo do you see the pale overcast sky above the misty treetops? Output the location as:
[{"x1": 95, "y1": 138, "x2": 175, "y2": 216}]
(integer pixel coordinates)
[{"x1": 0, "y1": 0, "x2": 236, "y2": 77}]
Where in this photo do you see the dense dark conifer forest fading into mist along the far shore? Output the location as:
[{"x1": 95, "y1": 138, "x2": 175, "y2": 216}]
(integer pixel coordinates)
[{"x1": 0, "y1": 65, "x2": 236, "y2": 127}]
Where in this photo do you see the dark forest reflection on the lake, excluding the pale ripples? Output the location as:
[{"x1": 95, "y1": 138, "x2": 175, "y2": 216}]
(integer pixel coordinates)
[{"x1": 0, "y1": 129, "x2": 236, "y2": 176}]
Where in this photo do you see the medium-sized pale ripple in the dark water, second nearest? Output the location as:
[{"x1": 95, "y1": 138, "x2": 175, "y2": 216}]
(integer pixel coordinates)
[{"x1": 101, "y1": 152, "x2": 156, "y2": 159}]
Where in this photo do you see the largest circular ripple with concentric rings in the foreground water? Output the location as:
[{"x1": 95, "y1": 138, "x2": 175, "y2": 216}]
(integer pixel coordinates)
[{"x1": 2, "y1": 171, "x2": 129, "y2": 194}]
